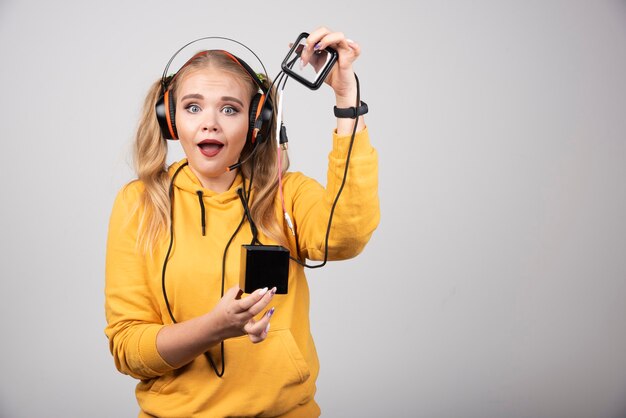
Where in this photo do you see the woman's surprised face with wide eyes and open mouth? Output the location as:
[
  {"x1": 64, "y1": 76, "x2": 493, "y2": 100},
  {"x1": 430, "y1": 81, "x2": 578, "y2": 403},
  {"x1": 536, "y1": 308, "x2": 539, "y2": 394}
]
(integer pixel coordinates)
[{"x1": 176, "y1": 69, "x2": 251, "y2": 192}]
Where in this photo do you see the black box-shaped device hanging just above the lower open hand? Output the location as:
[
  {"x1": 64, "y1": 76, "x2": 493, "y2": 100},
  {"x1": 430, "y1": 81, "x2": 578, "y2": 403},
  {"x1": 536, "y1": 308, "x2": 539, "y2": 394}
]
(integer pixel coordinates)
[{"x1": 239, "y1": 245, "x2": 289, "y2": 294}]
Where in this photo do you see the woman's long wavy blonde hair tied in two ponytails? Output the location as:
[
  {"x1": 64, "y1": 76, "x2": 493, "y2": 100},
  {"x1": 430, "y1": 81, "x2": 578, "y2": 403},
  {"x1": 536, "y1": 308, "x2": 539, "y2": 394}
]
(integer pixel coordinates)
[{"x1": 133, "y1": 51, "x2": 289, "y2": 253}]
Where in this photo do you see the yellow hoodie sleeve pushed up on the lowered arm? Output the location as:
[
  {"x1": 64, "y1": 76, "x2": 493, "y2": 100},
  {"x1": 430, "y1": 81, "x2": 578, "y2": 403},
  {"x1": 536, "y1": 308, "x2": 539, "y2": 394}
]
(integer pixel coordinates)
[{"x1": 105, "y1": 182, "x2": 173, "y2": 379}]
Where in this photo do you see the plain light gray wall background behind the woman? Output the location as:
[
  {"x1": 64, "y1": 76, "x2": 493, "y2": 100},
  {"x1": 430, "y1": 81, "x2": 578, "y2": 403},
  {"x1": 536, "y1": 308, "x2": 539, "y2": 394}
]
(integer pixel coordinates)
[{"x1": 0, "y1": 0, "x2": 626, "y2": 418}]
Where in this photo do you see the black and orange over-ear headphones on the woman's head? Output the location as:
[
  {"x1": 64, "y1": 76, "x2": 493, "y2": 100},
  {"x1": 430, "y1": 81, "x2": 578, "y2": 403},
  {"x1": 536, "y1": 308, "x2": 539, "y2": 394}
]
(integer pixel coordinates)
[{"x1": 154, "y1": 45, "x2": 274, "y2": 145}]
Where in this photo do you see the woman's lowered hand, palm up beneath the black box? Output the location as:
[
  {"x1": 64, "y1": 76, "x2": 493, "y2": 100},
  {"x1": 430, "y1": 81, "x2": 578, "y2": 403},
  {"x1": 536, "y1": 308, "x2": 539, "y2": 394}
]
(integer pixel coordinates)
[{"x1": 213, "y1": 286, "x2": 276, "y2": 343}]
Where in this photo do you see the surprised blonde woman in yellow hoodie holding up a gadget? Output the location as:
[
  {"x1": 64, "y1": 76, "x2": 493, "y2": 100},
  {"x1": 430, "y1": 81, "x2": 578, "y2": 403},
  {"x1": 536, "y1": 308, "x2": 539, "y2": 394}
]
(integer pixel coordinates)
[{"x1": 105, "y1": 28, "x2": 379, "y2": 417}]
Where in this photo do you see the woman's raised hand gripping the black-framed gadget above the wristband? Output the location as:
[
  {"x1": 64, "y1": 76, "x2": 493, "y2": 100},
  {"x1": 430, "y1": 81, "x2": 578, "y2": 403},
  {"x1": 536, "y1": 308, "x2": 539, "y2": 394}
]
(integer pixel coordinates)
[{"x1": 301, "y1": 27, "x2": 361, "y2": 102}]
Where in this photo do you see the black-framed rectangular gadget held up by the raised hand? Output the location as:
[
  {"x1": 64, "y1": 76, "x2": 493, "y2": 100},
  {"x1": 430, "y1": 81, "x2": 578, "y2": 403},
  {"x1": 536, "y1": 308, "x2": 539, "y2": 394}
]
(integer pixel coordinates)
[{"x1": 281, "y1": 32, "x2": 337, "y2": 90}]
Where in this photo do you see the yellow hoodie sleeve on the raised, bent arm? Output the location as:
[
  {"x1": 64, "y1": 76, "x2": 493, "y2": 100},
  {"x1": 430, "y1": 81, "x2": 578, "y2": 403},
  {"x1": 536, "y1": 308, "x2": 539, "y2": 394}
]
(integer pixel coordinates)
[{"x1": 291, "y1": 128, "x2": 380, "y2": 260}]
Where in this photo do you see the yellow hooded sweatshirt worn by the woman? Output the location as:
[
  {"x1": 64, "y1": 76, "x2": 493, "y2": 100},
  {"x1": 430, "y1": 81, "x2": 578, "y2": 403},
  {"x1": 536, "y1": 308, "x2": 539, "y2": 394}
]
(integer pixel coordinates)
[{"x1": 105, "y1": 129, "x2": 379, "y2": 418}]
